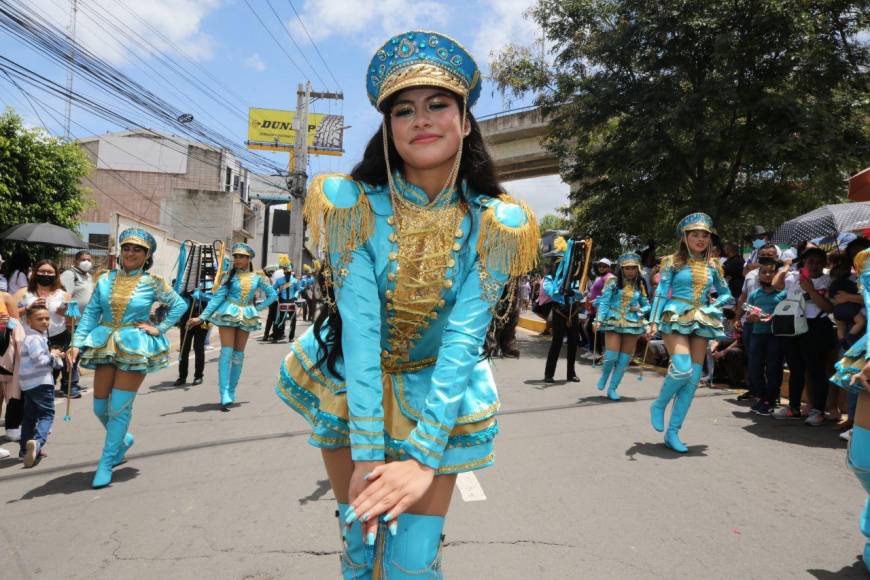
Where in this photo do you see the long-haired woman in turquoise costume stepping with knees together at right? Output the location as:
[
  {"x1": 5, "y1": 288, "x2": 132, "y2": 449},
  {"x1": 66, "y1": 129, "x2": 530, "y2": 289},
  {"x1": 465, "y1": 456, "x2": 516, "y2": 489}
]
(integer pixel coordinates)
[{"x1": 649, "y1": 213, "x2": 732, "y2": 453}]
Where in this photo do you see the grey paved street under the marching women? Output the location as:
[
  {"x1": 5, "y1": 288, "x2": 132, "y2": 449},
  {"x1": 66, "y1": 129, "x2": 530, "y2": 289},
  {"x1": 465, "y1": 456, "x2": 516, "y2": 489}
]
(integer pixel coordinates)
[{"x1": 0, "y1": 327, "x2": 866, "y2": 580}]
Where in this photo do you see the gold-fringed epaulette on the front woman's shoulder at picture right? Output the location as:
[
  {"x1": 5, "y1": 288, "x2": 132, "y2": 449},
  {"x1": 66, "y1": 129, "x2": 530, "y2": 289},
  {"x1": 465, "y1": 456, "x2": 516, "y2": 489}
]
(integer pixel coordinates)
[{"x1": 477, "y1": 196, "x2": 541, "y2": 276}]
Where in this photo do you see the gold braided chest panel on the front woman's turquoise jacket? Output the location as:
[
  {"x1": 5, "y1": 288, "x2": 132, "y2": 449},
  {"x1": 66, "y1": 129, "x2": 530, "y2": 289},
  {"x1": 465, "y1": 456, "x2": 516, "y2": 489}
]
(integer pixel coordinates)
[{"x1": 384, "y1": 196, "x2": 467, "y2": 363}]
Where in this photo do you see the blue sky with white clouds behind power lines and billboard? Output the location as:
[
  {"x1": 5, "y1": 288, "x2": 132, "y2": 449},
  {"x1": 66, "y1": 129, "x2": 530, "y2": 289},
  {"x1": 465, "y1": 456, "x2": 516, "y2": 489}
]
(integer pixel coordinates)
[{"x1": 0, "y1": 0, "x2": 567, "y2": 215}]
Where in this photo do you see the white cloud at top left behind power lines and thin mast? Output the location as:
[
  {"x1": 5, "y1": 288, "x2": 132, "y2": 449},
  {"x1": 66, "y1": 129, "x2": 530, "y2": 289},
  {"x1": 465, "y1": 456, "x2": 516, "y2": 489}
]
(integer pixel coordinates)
[{"x1": 30, "y1": 0, "x2": 222, "y2": 65}]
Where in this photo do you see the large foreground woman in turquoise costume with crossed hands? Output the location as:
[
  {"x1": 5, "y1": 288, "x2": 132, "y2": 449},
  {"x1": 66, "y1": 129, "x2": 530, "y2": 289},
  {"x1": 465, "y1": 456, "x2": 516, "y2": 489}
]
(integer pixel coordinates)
[{"x1": 276, "y1": 31, "x2": 538, "y2": 578}]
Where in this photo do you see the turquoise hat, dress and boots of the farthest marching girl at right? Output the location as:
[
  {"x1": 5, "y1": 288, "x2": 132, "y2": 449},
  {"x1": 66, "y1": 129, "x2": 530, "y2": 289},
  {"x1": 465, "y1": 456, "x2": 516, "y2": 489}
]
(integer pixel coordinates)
[{"x1": 595, "y1": 252, "x2": 650, "y2": 401}]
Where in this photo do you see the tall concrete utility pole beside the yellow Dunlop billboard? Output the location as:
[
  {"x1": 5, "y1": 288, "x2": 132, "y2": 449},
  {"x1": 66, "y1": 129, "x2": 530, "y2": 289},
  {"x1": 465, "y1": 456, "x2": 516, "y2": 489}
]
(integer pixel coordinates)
[{"x1": 287, "y1": 82, "x2": 344, "y2": 275}]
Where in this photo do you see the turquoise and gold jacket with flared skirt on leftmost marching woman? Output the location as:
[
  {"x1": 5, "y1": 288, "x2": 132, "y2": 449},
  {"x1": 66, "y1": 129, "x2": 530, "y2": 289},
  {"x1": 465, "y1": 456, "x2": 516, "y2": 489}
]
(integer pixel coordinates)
[{"x1": 72, "y1": 270, "x2": 187, "y2": 373}]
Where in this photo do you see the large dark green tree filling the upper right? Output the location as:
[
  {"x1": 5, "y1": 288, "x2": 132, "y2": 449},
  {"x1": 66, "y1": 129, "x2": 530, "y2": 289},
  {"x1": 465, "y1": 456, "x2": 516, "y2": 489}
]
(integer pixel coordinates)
[{"x1": 491, "y1": 0, "x2": 870, "y2": 254}]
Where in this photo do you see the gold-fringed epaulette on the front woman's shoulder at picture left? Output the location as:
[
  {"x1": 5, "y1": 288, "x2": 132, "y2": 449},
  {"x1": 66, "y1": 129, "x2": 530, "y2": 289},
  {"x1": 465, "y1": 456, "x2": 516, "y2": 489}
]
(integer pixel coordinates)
[{"x1": 302, "y1": 173, "x2": 374, "y2": 254}]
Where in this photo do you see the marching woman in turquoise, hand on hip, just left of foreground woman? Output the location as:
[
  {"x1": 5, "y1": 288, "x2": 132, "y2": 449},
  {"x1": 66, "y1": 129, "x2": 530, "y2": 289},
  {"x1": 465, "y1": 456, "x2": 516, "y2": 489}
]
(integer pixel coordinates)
[{"x1": 187, "y1": 243, "x2": 278, "y2": 411}]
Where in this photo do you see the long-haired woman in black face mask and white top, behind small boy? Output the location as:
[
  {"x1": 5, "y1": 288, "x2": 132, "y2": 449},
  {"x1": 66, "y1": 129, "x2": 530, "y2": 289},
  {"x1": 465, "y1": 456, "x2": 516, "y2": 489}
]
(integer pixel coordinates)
[{"x1": 15, "y1": 260, "x2": 72, "y2": 396}]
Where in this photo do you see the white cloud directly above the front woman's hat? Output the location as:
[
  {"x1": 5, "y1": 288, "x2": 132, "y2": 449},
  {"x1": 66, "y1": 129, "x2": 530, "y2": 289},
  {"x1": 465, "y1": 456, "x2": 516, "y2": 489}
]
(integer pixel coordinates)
[{"x1": 289, "y1": 0, "x2": 450, "y2": 49}]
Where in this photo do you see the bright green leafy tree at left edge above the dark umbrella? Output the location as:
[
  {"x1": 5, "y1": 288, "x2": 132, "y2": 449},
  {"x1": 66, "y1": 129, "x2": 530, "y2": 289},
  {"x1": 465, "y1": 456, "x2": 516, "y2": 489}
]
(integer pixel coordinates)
[{"x1": 0, "y1": 109, "x2": 90, "y2": 229}]
